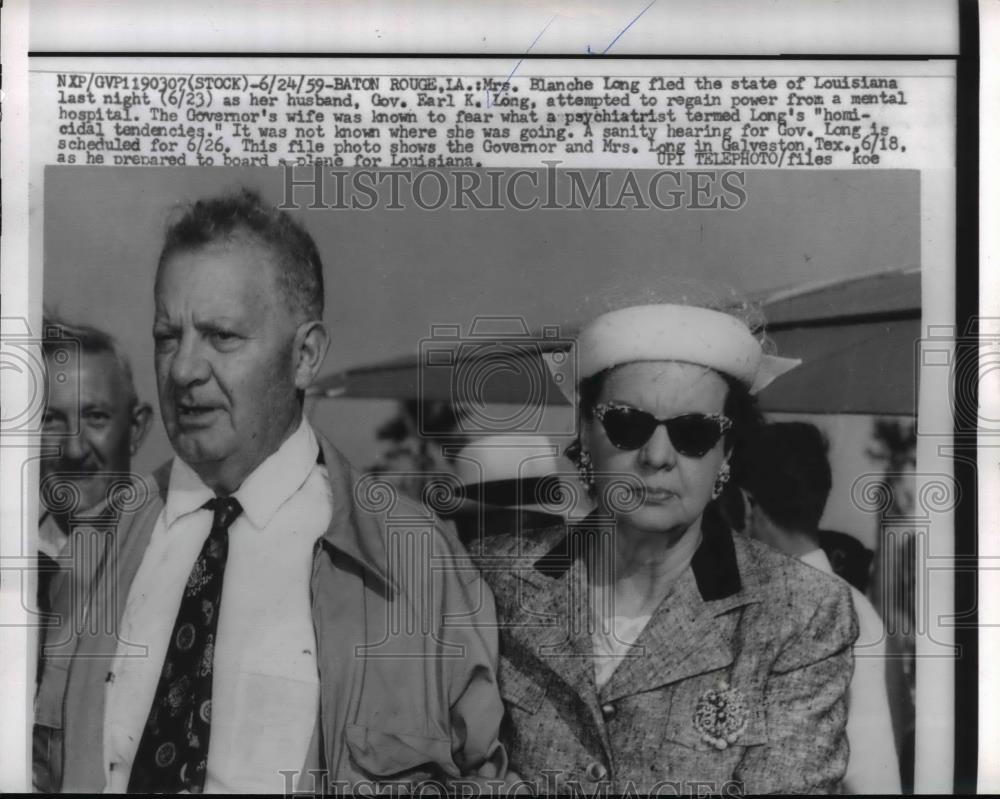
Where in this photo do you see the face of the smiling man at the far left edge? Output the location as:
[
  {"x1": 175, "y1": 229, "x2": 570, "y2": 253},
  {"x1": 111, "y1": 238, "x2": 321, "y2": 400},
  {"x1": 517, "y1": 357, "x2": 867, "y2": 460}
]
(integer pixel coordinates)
[{"x1": 40, "y1": 352, "x2": 142, "y2": 511}]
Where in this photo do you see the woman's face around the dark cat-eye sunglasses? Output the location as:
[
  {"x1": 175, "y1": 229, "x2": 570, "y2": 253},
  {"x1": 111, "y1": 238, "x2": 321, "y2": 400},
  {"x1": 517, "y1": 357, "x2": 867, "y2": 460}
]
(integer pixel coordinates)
[{"x1": 582, "y1": 361, "x2": 728, "y2": 533}]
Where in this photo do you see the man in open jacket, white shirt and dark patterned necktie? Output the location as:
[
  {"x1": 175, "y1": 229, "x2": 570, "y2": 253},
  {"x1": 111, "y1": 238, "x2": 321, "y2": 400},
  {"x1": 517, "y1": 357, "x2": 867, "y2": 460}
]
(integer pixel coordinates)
[{"x1": 42, "y1": 191, "x2": 506, "y2": 793}]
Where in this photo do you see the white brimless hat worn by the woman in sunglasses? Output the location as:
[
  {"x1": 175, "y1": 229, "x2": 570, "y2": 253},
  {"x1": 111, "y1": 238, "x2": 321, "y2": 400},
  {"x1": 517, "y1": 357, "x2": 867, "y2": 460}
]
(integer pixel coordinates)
[{"x1": 546, "y1": 304, "x2": 802, "y2": 394}]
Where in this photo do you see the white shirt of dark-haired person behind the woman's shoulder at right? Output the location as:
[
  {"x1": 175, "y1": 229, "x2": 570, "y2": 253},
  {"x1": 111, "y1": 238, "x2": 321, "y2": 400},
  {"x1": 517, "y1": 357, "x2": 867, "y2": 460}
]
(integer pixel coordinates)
[{"x1": 799, "y1": 549, "x2": 902, "y2": 794}]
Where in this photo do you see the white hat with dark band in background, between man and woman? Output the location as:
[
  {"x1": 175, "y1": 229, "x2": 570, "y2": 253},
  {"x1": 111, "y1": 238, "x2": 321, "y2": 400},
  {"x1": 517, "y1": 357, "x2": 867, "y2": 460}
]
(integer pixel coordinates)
[{"x1": 454, "y1": 435, "x2": 590, "y2": 515}]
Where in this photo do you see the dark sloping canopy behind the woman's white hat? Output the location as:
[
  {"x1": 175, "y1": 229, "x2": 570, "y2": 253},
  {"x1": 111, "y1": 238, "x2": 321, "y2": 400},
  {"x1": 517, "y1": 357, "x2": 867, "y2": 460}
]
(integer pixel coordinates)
[{"x1": 309, "y1": 270, "x2": 921, "y2": 415}]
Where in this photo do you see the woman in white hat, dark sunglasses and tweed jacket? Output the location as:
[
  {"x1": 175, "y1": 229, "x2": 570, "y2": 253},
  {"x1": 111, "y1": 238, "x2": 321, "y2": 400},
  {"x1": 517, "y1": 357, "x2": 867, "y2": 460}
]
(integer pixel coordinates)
[{"x1": 482, "y1": 305, "x2": 857, "y2": 794}]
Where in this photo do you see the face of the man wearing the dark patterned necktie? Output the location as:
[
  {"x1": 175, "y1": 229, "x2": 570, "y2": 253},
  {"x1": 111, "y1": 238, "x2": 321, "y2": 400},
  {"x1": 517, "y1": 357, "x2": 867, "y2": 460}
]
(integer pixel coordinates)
[{"x1": 153, "y1": 240, "x2": 301, "y2": 492}]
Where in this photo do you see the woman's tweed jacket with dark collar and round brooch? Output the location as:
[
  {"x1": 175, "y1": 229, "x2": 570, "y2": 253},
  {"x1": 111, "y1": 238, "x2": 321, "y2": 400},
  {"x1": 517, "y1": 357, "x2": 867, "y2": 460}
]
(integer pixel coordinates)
[{"x1": 477, "y1": 514, "x2": 857, "y2": 795}]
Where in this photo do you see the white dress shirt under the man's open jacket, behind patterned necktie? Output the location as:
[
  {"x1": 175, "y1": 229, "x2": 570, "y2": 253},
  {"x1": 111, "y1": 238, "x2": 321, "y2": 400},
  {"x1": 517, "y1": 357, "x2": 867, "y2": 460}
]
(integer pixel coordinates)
[{"x1": 104, "y1": 419, "x2": 333, "y2": 793}]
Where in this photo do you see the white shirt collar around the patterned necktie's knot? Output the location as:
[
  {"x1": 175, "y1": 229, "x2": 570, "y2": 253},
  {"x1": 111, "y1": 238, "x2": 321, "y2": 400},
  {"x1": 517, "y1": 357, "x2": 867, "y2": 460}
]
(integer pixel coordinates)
[{"x1": 164, "y1": 417, "x2": 319, "y2": 529}]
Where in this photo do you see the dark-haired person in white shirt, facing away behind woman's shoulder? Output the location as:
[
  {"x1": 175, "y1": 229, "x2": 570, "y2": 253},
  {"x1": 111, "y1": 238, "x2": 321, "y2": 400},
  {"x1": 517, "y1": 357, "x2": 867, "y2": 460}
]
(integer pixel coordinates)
[{"x1": 740, "y1": 422, "x2": 900, "y2": 794}]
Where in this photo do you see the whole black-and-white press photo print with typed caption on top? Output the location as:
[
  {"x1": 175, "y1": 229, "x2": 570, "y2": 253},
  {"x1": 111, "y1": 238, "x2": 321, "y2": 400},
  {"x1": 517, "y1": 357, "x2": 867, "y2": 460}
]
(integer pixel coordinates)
[{"x1": 2, "y1": 0, "x2": 994, "y2": 796}]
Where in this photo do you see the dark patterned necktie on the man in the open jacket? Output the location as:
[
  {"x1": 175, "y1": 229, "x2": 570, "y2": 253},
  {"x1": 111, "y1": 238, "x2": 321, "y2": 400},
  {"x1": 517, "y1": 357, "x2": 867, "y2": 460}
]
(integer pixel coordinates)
[{"x1": 128, "y1": 497, "x2": 243, "y2": 793}]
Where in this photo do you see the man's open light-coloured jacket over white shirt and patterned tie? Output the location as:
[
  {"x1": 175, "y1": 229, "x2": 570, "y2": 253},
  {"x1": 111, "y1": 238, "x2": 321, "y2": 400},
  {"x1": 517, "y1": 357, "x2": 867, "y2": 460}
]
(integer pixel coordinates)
[{"x1": 36, "y1": 438, "x2": 506, "y2": 792}]
